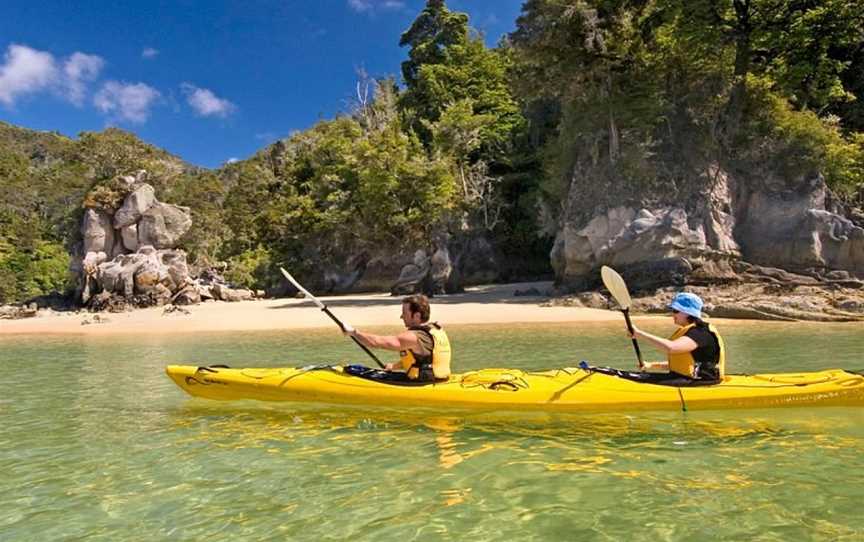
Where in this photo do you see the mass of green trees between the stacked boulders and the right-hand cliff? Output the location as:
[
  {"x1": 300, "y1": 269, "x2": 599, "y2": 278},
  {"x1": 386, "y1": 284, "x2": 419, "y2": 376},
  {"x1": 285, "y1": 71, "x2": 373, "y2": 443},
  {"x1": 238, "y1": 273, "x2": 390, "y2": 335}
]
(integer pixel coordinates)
[{"x1": 214, "y1": 0, "x2": 549, "y2": 287}]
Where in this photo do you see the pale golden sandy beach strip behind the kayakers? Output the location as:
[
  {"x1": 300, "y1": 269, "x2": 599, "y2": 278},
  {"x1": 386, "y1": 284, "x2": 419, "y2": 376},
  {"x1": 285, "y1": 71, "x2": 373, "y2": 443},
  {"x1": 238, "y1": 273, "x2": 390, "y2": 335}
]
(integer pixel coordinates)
[{"x1": 0, "y1": 282, "x2": 621, "y2": 335}]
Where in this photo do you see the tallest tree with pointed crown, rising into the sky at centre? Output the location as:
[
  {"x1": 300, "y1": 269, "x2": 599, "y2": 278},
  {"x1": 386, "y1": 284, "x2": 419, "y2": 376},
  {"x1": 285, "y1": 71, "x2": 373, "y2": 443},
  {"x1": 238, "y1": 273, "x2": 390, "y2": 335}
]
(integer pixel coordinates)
[{"x1": 399, "y1": 0, "x2": 550, "y2": 278}]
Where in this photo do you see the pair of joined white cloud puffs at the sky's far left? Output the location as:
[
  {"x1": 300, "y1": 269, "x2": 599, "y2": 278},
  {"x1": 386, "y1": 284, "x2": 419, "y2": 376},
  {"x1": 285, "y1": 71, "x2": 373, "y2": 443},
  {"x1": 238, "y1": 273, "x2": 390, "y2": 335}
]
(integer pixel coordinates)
[{"x1": 0, "y1": 44, "x2": 105, "y2": 107}]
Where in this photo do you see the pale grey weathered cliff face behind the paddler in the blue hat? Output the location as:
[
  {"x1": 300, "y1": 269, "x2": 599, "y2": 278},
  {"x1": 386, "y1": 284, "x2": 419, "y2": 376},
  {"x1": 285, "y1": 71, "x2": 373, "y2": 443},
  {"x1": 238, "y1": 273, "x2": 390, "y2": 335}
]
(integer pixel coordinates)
[{"x1": 550, "y1": 169, "x2": 864, "y2": 289}]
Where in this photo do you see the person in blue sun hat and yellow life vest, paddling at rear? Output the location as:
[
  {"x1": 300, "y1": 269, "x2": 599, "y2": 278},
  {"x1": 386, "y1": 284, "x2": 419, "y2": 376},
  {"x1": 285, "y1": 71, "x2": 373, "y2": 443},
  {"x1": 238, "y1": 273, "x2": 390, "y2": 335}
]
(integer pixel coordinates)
[{"x1": 631, "y1": 292, "x2": 726, "y2": 383}]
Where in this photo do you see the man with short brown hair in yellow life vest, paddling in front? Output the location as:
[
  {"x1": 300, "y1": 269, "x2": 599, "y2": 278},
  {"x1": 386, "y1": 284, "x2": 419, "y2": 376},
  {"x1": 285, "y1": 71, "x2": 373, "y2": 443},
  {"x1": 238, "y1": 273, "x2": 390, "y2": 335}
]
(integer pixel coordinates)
[{"x1": 343, "y1": 294, "x2": 451, "y2": 383}]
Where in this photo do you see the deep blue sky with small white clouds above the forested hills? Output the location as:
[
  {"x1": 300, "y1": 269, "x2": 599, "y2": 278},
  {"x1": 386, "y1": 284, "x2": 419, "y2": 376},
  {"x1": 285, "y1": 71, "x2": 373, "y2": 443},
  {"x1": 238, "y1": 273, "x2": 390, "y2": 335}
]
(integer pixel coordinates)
[{"x1": 0, "y1": 0, "x2": 522, "y2": 167}]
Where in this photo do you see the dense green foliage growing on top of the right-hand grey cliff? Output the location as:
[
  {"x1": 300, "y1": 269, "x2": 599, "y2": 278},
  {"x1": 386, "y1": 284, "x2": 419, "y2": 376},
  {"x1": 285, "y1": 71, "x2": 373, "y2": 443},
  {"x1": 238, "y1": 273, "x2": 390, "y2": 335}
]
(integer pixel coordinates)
[{"x1": 512, "y1": 0, "x2": 864, "y2": 214}]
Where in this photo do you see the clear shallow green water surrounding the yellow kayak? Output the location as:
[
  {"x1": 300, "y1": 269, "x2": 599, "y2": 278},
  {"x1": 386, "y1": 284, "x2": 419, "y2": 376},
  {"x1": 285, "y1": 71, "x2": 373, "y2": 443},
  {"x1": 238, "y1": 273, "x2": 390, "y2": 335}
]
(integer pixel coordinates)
[{"x1": 0, "y1": 322, "x2": 864, "y2": 541}]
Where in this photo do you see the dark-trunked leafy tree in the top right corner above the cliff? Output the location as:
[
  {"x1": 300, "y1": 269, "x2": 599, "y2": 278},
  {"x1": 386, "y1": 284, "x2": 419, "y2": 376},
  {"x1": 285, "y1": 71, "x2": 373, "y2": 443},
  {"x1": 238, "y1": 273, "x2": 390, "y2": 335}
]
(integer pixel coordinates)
[{"x1": 658, "y1": 0, "x2": 864, "y2": 145}]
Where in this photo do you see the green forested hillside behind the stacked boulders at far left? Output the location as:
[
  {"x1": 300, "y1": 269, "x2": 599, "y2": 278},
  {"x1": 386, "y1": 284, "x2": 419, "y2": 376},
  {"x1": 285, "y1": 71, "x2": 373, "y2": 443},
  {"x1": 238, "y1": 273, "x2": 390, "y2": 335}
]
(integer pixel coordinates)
[{"x1": 0, "y1": 123, "x2": 202, "y2": 303}]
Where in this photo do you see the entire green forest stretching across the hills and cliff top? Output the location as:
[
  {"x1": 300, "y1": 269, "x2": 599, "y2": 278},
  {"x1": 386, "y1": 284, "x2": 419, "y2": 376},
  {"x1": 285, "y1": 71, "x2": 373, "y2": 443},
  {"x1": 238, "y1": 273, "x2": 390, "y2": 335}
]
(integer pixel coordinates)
[{"x1": 0, "y1": 0, "x2": 864, "y2": 303}]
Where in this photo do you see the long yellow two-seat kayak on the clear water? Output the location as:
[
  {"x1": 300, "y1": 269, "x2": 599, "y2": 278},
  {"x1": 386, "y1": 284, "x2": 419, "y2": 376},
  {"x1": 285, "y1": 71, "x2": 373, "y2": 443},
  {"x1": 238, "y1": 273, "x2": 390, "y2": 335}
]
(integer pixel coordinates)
[{"x1": 166, "y1": 365, "x2": 864, "y2": 412}]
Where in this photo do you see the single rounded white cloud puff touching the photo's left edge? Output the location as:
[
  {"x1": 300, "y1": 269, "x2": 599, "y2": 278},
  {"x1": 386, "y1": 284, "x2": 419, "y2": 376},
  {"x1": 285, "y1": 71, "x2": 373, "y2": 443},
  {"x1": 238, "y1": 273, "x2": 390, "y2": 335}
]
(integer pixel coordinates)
[{"x1": 0, "y1": 44, "x2": 58, "y2": 107}]
